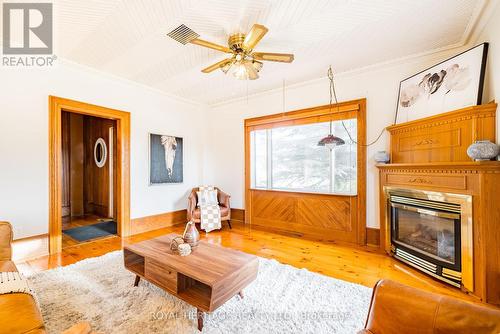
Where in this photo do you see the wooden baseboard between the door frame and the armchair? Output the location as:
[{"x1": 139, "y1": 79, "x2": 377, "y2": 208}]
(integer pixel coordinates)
[{"x1": 130, "y1": 209, "x2": 187, "y2": 235}]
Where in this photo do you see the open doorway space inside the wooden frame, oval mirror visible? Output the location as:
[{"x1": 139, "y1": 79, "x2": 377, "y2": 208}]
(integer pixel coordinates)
[{"x1": 61, "y1": 110, "x2": 118, "y2": 248}]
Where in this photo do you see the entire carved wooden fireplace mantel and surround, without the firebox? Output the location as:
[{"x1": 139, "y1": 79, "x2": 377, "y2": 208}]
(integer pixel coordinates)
[{"x1": 377, "y1": 103, "x2": 500, "y2": 305}]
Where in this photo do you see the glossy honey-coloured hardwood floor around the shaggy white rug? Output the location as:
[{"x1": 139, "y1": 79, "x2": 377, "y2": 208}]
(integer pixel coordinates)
[{"x1": 18, "y1": 222, "x2": 484, "y2": 301}]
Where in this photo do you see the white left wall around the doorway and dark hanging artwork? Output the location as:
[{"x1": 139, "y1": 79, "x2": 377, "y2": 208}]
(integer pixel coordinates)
[{"x1": 0, "y1": 64, "x2": 204, "y2": 239}]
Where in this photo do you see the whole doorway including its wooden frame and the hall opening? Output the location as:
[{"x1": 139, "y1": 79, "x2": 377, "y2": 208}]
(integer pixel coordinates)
[{"x1": 49, "y1": 96, "x2": 130, "y2": 254}]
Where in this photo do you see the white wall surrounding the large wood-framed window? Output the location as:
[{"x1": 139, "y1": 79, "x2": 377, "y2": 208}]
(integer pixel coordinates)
[{"x1": 204, "y1": 32, "x2": 500, "y2": 227}]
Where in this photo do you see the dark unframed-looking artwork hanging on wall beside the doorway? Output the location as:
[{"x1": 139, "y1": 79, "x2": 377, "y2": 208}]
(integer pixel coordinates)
[{"x1": 149, "y1": 133, "x2": 184, "y2": 185}]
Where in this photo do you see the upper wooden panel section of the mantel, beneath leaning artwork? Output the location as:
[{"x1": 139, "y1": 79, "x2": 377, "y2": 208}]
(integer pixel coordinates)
[{"x1": 387, "y1": 103, "x2": 497, "y2": 163}]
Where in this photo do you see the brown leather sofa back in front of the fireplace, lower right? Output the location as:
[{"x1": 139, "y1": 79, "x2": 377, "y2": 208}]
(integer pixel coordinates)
[{"x1": 358, "y1": 280, "x2": 500, "y2": 334}]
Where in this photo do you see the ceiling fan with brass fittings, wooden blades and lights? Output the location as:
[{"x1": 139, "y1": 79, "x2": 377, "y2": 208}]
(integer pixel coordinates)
[{"x1": 167, "y1": 24, "x2": 293, "y2": 80}]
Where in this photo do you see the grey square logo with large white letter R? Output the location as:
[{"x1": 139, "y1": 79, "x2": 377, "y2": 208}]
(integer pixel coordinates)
[{"x1": 3, "y1": 3, "x2": 53, "y2": 55}]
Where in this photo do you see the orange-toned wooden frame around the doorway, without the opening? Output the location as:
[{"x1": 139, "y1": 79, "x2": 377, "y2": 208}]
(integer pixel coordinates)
[{"x1": 49, "y1": 96, "x2": 131, "y2": 254}]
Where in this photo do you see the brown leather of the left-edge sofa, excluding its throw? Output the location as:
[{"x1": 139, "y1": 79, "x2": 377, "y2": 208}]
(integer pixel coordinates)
[{"x1": 0, "y1": 221, "x2": 94, "y2": 334}]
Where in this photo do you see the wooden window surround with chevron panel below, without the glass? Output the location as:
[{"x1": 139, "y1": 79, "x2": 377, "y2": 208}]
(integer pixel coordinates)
[{"x1": 245, "y1": 99, "x2": 366, "y2": 245}]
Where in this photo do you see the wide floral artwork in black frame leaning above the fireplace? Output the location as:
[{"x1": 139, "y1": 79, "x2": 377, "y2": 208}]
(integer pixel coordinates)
[{"x1": 395, "y1": 43, "x2": 488, "y2": 124}]
